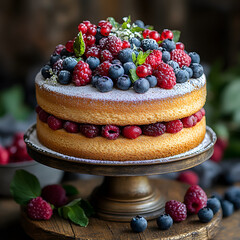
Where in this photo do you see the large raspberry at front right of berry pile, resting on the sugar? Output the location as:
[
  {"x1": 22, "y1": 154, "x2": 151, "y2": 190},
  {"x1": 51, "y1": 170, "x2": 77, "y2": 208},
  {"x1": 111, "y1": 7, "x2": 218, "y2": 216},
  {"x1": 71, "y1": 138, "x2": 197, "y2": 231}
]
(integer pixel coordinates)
[{"x1": 154, "y1": 62, "x2": 176, "y2": 89}]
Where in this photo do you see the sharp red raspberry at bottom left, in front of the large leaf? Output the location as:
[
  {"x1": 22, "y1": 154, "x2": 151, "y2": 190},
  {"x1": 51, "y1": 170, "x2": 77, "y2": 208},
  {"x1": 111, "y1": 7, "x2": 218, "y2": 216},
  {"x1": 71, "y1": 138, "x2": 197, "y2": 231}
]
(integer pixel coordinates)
[{"x1": 27, "y1": 197, "x2": 53, "y2": 220}]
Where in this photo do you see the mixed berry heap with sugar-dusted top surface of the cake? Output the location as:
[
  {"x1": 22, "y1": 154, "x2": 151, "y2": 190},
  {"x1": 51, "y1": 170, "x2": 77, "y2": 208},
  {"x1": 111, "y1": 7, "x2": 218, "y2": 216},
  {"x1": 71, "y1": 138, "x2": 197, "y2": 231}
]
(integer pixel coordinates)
[{"x1": 41, "y1": 17, "x2": 205, "y2": 94}]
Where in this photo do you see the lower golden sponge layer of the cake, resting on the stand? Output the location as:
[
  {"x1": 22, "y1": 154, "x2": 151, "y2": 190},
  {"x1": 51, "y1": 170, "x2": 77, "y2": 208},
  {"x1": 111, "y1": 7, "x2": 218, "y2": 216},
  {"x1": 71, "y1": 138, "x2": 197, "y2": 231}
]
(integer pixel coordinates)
[{"x1": 37, "y1": 117, "x2": 206, "y2": 161}]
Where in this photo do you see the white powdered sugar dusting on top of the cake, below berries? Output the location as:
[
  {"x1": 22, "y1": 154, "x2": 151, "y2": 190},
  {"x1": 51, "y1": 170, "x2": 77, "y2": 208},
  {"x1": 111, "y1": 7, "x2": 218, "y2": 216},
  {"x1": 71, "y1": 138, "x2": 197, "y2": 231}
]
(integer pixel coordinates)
[{"x1": 35, "y1": 73, "x2": 206, "y2": 102}]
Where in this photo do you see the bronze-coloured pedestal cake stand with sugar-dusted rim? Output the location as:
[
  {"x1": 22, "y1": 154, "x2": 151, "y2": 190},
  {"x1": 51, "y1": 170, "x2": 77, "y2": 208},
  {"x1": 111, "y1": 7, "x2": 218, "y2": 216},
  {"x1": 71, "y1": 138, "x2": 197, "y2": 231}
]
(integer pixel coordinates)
[{"x1": 25, "y1": 125, "x2": 221, "y2": 239}]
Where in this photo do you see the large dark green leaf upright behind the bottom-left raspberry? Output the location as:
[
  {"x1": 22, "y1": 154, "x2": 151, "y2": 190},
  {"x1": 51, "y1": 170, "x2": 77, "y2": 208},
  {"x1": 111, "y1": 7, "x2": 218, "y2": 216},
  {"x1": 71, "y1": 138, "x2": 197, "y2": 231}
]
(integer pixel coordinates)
[{"x1": 10, "y1": 170, "x2": 41, "y2": 205}]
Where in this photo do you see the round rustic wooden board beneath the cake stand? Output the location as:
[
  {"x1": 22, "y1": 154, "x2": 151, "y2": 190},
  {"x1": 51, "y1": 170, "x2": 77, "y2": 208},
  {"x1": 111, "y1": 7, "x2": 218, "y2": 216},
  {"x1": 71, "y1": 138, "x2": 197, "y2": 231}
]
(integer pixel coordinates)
[{"x1": 22, "y1": 178, "x2": 222, "y2": 240}]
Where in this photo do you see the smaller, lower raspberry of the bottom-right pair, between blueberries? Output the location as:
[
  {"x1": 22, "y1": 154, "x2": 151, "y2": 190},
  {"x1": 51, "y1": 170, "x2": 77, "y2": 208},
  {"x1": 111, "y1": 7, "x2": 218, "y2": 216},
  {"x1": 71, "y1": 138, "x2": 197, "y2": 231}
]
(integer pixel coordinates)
[{"x1": 165, "y1": 200, "x2": 187, "y2": 222}]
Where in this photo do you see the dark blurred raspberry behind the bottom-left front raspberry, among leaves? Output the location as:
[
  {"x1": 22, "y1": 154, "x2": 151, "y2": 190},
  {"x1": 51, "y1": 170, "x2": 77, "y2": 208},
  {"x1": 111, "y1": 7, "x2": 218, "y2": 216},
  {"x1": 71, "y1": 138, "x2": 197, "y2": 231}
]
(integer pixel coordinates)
[{"x1": 41, "y1": 184, "x2": 68, "y2": 207}]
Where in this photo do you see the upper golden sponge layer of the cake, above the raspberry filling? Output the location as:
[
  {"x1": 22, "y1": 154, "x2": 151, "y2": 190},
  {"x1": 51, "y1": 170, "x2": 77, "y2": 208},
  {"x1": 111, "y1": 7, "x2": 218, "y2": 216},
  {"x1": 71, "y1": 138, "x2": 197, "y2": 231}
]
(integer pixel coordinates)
[{"x1": 36, "y1": 80, "x2": 206, "y2": 126}]
